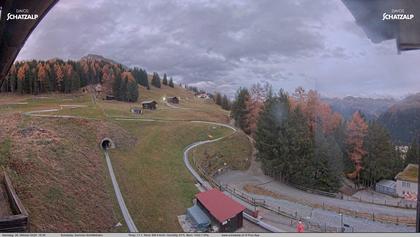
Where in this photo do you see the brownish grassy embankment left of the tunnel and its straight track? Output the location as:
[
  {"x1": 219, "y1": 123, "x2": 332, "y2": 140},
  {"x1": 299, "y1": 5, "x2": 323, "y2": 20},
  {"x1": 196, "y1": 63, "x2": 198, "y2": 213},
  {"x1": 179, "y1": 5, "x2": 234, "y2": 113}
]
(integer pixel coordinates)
[{"x1": 0, "y1": 113, "x2": 134, "y2": 232}]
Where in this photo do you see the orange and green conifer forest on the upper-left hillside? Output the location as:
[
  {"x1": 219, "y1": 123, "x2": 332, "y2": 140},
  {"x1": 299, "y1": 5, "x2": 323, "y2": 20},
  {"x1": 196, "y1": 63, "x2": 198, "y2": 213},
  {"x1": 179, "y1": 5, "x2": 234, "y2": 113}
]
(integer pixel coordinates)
[{"x1": 0, "y1": 55, "x2": 153, "y2": 102}]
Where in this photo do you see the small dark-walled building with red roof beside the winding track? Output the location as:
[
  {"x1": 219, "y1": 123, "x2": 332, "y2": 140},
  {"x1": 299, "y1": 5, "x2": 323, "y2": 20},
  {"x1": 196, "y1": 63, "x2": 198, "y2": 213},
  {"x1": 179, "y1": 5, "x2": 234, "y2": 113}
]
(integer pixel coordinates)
[{"x1": 196, "y1": 189, "x2": 245, "y2": 232}]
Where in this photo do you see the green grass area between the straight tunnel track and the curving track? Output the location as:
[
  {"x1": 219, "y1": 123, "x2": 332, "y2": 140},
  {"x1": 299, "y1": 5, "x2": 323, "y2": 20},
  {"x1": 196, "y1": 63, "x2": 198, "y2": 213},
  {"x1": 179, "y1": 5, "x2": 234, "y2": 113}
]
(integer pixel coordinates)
[{"x1": 110, "y1": 121, "x2": 231, "y2": 232}]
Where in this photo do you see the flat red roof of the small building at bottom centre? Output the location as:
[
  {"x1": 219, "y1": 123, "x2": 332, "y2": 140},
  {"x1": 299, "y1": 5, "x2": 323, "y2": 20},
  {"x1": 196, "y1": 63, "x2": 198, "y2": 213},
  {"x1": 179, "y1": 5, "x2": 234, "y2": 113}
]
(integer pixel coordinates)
[{"x1": 195, "y1": 189, "x2": 245, "y2": 223}]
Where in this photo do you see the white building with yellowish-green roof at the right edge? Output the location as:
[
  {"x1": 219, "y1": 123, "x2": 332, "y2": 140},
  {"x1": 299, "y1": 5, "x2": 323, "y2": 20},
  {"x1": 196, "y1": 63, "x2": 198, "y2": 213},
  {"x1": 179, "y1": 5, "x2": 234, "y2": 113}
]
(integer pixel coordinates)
[{"x1": 395, "y1": 164, "x2": 418, "y2": 200}]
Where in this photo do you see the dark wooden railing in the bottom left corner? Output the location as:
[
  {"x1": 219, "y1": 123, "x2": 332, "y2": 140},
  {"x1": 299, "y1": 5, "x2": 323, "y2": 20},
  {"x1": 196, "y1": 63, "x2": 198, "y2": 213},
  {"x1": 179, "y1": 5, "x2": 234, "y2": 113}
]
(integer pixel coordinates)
[{"x1": 0, "y1": 173, "x2": 29, "y2": 232}]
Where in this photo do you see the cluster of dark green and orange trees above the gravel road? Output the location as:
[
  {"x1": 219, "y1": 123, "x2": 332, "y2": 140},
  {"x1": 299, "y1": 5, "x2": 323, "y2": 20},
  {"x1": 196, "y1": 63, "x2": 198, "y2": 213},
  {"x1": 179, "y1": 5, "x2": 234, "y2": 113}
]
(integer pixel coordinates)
[{"x1": 232, "y1": 84, "x2": 404, "y2": 191}]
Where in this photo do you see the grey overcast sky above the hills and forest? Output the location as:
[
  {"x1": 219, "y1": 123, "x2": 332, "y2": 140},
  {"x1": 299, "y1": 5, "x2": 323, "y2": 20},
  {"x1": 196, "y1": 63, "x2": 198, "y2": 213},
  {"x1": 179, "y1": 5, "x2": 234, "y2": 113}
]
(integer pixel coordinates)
[{"x1": 18, "y1": 0, "x2": 420, "y2": 97}]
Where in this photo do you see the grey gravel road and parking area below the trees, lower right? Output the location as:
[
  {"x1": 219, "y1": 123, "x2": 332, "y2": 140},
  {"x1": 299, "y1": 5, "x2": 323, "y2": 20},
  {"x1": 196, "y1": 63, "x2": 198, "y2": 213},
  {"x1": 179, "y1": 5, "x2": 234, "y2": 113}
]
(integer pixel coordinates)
[{"x1": 216, "y1": 171, "x2": 415, "y2": 232}]
